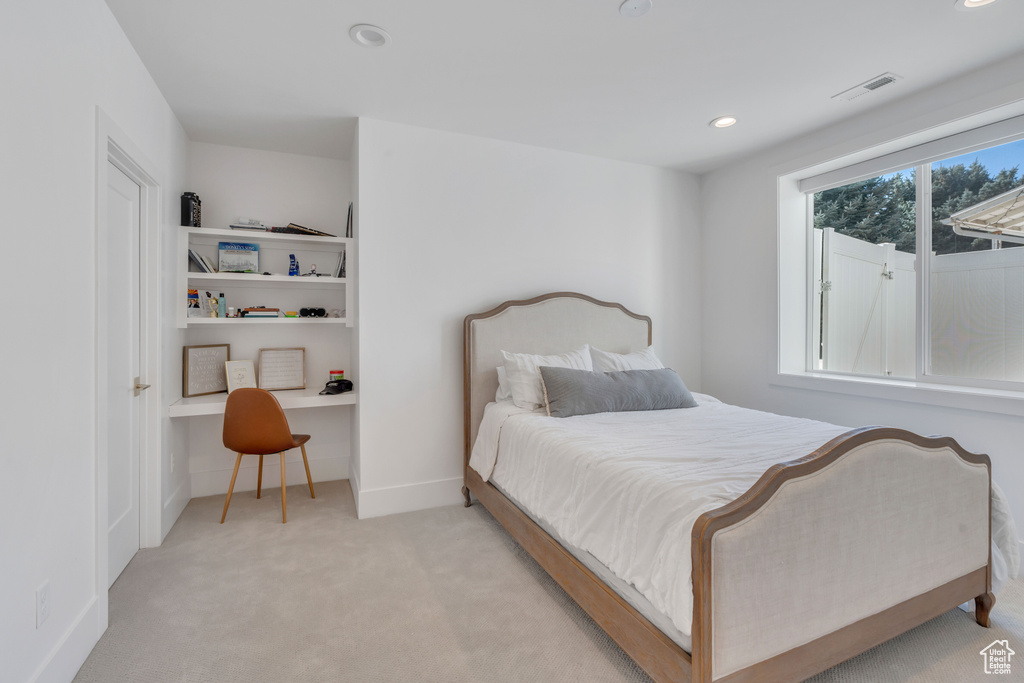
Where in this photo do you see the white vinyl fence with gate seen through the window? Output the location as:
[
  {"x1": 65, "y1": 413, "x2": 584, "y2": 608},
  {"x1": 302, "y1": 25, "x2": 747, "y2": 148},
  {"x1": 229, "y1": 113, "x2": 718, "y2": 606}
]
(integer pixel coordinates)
[{"x1": 812, "y1": 227, "x2": 1024, "y2": 381}]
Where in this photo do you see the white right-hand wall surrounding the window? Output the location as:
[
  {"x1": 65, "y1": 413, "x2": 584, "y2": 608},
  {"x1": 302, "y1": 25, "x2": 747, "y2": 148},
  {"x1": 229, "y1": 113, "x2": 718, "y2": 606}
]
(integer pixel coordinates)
[{"x1": 700, "y1": 50, "x2": 1024, "y2": 536}]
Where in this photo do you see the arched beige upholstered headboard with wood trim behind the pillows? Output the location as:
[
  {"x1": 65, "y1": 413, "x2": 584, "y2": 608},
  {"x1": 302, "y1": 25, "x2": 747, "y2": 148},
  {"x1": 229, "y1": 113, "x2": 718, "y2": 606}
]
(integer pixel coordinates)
[{"x1": 463, "y1": 292, "x2": 651, "y2": 473}]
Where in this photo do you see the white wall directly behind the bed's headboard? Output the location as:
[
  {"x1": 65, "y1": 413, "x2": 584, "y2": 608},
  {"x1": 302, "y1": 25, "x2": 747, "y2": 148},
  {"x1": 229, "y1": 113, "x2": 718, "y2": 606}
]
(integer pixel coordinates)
[{"x1": 356, "y1": 119, "x2": 701, "y2": 517}]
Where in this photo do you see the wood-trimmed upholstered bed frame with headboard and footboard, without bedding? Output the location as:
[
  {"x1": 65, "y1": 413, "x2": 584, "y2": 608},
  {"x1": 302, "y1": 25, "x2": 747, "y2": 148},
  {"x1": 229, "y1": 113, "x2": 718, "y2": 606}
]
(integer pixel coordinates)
[{"x1": 463, "y1": 292, "x2": 994, "y2": 683}]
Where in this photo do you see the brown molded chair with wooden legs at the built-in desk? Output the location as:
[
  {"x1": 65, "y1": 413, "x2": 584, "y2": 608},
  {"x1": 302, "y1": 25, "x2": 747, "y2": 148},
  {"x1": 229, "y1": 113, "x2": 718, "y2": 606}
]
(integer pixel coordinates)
[{"x1": 220, "y1": 389, "x2": 316, "y2": 524}]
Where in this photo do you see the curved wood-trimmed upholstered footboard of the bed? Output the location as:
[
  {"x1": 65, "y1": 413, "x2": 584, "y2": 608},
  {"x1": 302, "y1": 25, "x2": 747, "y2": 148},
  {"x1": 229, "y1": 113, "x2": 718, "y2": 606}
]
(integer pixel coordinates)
[{"x1": 692, "y1": 428, "x2": 992, "y2": 682}]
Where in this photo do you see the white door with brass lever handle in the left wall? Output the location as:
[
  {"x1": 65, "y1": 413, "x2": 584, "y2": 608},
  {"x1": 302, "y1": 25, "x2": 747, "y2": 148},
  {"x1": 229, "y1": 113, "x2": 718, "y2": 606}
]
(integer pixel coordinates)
[{"x1": 105, "y1": 162, "x2": 141, "y2": 587}]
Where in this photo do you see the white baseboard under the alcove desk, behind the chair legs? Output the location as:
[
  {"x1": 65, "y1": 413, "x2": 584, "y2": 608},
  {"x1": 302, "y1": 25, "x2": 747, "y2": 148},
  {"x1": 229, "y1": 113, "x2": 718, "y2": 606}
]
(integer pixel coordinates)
[{"x1": 188, "y1": 454, "x2": 348, "y2": 498}]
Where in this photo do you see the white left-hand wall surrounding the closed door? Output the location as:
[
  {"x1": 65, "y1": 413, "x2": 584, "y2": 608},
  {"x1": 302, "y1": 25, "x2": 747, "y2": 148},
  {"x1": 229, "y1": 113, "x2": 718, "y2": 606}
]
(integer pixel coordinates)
[{"x1": 0, "y1": 0, "x2": 187, "y2": 681}]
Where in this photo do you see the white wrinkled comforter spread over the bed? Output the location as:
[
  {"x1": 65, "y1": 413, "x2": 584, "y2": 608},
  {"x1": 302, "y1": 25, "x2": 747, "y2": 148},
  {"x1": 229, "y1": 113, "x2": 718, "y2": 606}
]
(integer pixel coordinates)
[{"x1": 470, "y1": 394, "x2": 1019, "y2": 635}]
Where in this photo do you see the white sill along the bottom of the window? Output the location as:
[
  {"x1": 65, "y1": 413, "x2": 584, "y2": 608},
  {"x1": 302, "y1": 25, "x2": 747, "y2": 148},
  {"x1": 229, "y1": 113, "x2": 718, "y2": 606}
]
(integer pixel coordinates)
[{"x1": 771, "y1": 373, "x2": 1024, "y2": 417}]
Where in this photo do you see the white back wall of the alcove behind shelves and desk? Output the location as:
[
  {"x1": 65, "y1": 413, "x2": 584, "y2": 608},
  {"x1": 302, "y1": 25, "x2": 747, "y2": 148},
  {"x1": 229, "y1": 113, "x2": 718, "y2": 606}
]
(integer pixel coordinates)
[{"x1": 186, "y1": 142, "x2": 352, "y2": 497}]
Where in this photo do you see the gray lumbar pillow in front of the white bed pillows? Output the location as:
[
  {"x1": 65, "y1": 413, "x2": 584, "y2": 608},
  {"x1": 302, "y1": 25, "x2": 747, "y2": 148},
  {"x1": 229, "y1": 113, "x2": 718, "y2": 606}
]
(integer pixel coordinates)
[{"x1": 540, "y1": 366, "x2": 697, "y2": 418}]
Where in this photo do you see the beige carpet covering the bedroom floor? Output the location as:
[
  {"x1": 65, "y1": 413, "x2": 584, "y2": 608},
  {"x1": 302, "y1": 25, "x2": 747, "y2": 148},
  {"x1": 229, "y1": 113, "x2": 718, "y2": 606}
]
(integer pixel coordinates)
[{"x1": 75, "y1": 481, "x2": 1024, "y2": 683}]
